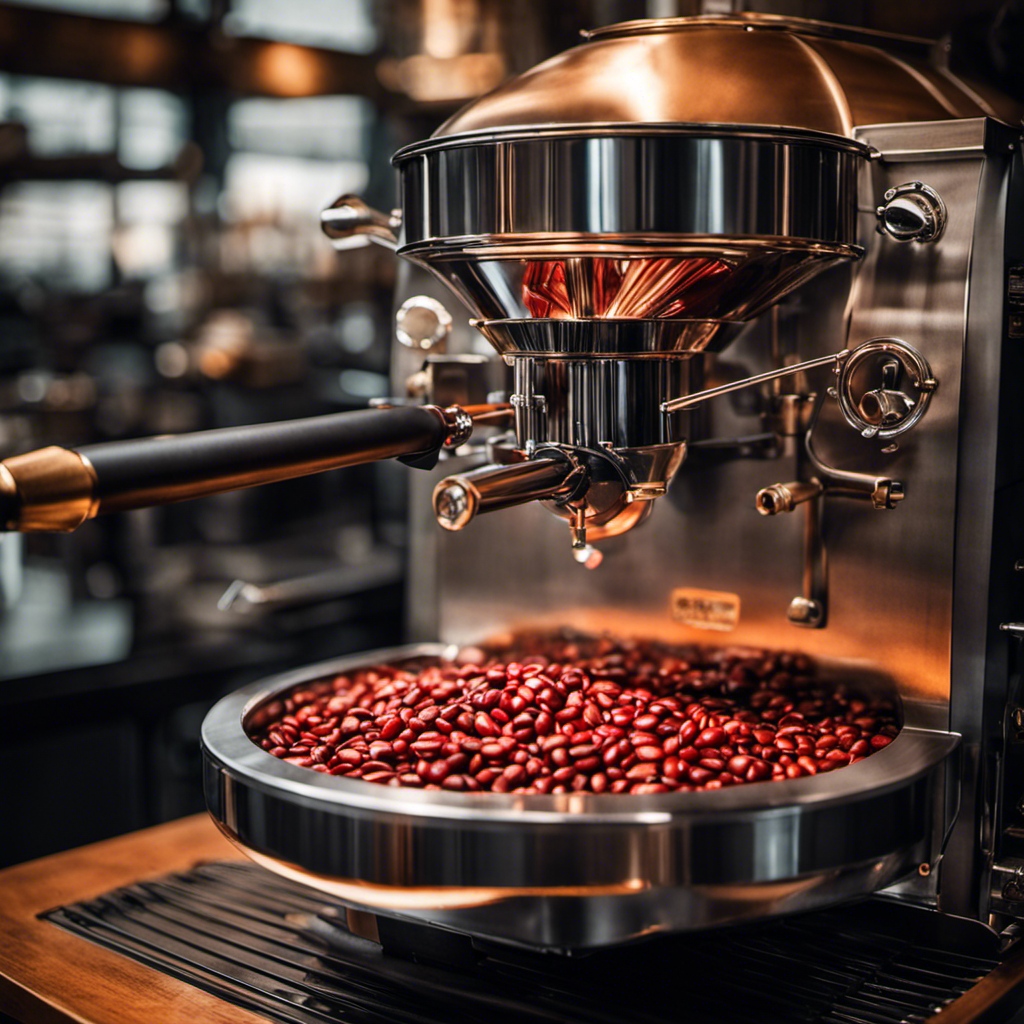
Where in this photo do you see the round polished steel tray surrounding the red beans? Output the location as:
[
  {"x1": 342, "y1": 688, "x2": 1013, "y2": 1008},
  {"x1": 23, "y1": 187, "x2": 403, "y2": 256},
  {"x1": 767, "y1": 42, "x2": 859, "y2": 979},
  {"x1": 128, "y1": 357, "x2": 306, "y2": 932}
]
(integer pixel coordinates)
[{"x1": 203, "y1": 644, "x2": 957, "y2": 949}]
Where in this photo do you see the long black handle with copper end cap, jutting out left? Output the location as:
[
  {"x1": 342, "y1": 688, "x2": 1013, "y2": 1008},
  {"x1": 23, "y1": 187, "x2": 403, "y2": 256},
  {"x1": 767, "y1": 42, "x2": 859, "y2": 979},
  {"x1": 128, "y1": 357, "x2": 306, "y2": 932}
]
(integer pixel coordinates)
[{"x1": 0, "y1": 406, "x2": 479, "y2": 532}]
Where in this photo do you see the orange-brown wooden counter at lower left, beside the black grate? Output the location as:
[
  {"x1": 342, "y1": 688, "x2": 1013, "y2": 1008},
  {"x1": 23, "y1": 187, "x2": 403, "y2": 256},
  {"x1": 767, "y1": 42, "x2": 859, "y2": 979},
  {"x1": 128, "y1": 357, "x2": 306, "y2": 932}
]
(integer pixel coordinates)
[{"x1": 0, "y1": 814, "x2": 266, "y2": 1024}]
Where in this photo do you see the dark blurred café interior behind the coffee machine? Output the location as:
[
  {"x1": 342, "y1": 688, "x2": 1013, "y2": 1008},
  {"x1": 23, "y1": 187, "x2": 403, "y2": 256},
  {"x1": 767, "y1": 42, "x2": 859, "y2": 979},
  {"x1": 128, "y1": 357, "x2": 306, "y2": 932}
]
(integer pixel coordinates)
[{"x1": 0, "y1": 0, "x2": 1024, "y2": 866}]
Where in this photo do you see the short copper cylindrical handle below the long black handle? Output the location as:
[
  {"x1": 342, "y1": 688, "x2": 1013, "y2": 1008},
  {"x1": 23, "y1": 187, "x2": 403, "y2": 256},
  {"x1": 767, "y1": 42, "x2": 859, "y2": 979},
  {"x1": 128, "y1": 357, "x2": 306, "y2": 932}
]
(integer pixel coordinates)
[{"x1": 433, "y1": 458, "x2": 583, "y2": 530}]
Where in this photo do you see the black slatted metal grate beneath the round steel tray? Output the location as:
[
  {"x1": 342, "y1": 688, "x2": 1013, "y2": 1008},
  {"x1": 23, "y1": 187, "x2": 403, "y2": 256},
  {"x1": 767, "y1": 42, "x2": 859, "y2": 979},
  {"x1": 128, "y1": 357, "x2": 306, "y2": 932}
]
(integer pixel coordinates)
[{"x1": 43, "y1": 863, "x2": 998, "y2": 1024}]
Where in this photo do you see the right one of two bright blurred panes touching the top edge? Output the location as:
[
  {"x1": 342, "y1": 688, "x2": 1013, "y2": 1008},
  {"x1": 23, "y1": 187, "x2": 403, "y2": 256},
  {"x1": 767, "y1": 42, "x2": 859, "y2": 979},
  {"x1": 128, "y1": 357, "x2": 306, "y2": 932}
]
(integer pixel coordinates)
[{"x1": 224, "y1": 0, "x2": 377, "y2": 53}]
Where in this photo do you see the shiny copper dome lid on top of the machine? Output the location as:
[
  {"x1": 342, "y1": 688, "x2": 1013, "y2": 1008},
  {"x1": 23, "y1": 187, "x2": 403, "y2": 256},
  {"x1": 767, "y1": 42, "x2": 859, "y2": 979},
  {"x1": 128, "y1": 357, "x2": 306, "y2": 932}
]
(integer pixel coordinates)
[{"x1": 437, "y1": 13, "x2": 1020, "y2": 137}]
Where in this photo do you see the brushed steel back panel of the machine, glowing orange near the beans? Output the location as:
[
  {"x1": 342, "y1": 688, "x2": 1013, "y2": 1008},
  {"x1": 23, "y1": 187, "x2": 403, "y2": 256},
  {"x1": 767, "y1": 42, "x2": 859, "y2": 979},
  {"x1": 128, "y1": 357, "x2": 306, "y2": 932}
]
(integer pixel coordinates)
[{"x1": 413, "y1": 142, "x2": 982, "y2": 727}]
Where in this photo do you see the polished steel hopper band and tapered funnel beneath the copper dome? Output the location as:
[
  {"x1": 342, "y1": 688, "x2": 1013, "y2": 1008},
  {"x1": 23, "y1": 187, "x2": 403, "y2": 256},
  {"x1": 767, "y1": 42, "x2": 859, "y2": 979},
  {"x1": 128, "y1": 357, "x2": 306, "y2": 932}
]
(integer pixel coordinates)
[{"x1": 394, "y1": 132, "x2": 866, "y2": 321}]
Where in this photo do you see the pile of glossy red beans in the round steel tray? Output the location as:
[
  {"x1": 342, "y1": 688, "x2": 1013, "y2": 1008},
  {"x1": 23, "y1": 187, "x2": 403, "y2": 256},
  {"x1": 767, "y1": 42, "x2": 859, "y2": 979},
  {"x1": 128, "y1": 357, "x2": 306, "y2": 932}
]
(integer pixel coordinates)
[{"x1": 253, "y1": 638, "x2": 899, "y2": 794}]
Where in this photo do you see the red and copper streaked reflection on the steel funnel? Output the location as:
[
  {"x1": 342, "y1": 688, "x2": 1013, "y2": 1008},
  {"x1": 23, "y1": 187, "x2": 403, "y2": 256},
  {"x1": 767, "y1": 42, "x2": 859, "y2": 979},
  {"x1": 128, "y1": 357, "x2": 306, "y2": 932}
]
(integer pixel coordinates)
[{"x1": 522, "y1": 256, "x2": 732, "y2": 319}]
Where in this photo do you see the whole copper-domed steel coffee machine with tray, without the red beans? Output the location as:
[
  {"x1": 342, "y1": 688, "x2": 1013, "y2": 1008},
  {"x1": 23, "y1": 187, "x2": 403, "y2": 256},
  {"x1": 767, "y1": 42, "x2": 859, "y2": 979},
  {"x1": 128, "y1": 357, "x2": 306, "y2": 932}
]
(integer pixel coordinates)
[{"x1": 6, "y1": 15, "x2": 1024, "y2": 949}]
